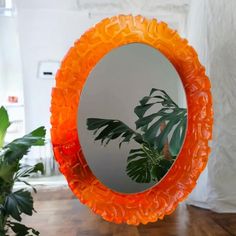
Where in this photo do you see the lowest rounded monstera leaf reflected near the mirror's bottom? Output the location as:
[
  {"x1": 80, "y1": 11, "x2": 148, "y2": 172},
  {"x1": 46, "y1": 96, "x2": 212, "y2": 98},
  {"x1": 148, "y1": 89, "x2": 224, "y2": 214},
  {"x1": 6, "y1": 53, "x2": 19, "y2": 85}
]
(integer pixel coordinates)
[{"x1": 126, "y1": 145, "x2": 173, "y2": 183}]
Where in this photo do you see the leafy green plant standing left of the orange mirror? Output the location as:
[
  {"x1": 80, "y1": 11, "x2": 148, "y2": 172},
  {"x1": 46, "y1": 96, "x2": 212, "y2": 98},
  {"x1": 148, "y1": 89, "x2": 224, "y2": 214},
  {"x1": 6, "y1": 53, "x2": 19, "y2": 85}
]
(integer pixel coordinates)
[{"x1": 0, "y1": 107, "x2": 45, "y2": 236}]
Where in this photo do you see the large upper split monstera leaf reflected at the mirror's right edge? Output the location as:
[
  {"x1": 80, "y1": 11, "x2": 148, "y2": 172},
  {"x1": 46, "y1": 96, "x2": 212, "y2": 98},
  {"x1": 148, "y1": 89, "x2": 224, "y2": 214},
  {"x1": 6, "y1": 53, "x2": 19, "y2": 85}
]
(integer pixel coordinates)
[{"x1": 134, "y1": 89, "x2": 187, "y2": 156}]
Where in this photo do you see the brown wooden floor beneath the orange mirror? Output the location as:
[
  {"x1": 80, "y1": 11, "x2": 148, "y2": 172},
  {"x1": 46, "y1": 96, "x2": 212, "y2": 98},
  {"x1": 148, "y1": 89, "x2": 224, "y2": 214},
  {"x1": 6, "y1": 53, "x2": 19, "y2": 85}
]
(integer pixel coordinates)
[{"x1": 20, "y1": 190, "x2": 236, "y2": 236}]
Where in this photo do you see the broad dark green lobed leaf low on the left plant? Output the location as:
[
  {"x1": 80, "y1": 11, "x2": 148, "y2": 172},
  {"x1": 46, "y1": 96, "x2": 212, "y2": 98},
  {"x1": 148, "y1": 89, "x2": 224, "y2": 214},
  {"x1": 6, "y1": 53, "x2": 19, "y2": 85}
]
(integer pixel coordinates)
[{"x1": 4, "y1": 189, "x2": 34, "y2": 221}]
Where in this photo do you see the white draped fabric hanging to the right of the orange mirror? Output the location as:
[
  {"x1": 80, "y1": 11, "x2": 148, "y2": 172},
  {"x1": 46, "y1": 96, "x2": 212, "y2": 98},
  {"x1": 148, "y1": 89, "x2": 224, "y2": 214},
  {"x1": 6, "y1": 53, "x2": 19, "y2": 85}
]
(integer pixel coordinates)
[{"x1": 187, "y1": 0, "x2": 236, "y2": 212}]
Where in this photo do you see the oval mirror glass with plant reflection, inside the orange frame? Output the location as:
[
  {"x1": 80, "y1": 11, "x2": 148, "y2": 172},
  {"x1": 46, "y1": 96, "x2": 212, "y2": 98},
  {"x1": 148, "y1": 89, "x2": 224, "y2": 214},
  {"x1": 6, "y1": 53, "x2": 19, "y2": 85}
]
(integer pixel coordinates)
[{"x1": 78, "y1": 43, "x2": 187, "y2": 193}]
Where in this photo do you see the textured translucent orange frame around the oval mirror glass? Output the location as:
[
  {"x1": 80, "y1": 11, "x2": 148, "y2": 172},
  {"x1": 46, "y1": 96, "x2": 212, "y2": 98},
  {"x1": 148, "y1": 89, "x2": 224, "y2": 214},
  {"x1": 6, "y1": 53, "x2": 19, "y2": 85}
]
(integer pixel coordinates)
[{"x1": 51, "y1": 15, "x2": 213, "y2": 225}]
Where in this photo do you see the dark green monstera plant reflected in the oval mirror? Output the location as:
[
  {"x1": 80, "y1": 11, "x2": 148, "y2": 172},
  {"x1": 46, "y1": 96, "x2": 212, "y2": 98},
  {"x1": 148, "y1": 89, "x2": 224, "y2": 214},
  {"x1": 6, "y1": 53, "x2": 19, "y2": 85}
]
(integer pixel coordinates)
[{"x1": 87, "y1": 88, "x2": 187, "y2": 183}]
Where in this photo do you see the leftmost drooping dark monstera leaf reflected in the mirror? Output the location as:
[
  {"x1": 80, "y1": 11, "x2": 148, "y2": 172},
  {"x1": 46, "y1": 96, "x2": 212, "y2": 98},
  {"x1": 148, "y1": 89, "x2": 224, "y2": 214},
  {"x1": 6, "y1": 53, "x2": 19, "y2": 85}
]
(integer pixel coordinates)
[{"x1": 87, "y1": 118, "x2": 142, "y2": 145}]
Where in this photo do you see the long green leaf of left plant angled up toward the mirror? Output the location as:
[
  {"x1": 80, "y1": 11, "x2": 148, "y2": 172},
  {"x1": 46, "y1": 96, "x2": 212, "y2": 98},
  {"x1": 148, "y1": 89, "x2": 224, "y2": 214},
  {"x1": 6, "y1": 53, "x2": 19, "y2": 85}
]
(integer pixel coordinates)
[{"x1": 3, "y1": 127, "x2": 46, "y2": 163}]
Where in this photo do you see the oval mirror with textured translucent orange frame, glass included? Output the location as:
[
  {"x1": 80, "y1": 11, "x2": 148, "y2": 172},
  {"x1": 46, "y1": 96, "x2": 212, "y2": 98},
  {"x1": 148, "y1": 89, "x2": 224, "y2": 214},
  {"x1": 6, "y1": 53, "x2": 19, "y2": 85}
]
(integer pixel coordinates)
[{"x1": 51, "y1": 15, "x2": 213, "y2": 225}]
